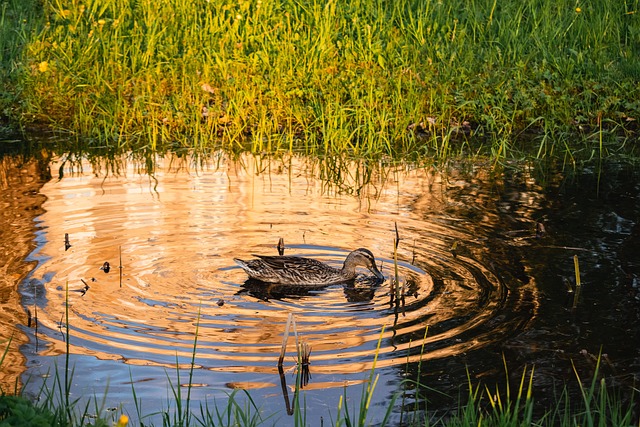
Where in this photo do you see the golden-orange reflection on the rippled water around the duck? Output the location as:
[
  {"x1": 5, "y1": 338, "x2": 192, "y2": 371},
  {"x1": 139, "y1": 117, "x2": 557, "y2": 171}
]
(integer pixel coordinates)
[{"x1": 26, "y1": 156, "x2": 537, "y2": 386}]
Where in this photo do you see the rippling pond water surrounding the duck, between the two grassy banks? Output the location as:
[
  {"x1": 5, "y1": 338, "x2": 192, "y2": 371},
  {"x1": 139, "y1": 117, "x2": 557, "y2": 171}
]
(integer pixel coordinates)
[{"x1": 2, "y1": 147, "x2": 640, "y2": 425}]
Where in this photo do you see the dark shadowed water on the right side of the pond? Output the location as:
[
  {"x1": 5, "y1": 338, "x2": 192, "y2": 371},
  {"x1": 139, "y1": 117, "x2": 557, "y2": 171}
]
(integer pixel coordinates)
[{"x1": 398, "y1": 164, "x2": 640, "y2": 422}]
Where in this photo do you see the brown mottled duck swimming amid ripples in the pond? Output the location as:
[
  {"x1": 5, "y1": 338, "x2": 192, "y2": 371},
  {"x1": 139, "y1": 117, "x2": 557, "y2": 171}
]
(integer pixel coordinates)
[{"x1": 234, "y1": 248, "x2": 384, "y2": 286}]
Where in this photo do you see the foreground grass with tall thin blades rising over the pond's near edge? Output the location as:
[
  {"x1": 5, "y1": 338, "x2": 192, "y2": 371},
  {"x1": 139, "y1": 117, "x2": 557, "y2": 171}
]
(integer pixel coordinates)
[{"x1": 0, "y1": 300, "x2": 640, "y2": 427}]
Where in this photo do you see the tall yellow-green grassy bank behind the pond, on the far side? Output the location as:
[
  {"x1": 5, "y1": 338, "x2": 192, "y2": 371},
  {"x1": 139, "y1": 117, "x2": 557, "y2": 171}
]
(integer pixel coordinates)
[{"x1": 2, "y1": 0, "x2": 640, "y2": 162}]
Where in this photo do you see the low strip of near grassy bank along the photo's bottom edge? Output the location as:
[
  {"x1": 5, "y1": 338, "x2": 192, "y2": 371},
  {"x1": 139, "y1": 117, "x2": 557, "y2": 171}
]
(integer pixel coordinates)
[{"x1": 0, "y1": 354, "x2": 640, "y2": 427}]
